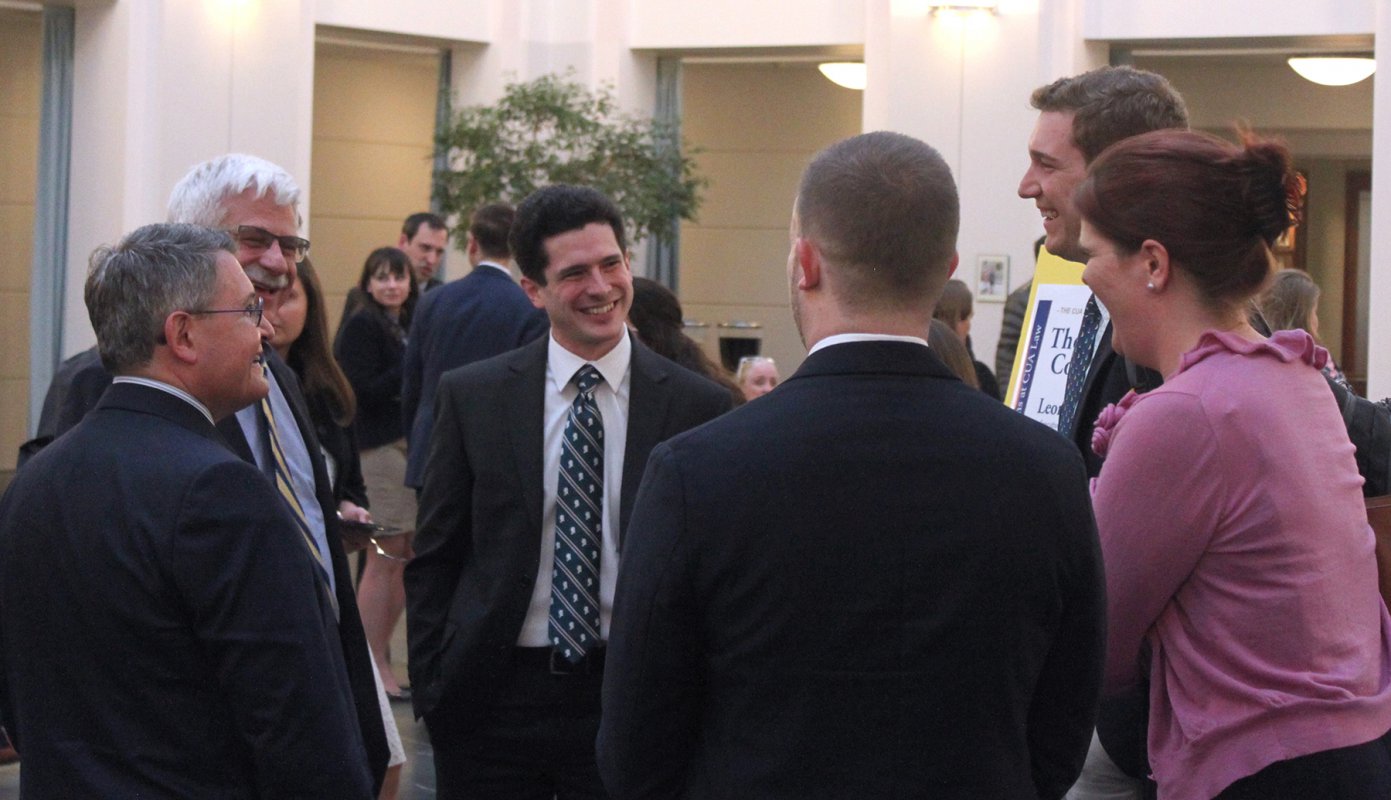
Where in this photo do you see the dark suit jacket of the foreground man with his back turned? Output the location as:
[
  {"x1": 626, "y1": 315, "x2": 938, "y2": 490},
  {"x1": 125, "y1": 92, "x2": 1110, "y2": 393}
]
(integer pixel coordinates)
[{"x1": 598, "y1": 342, "x2": 1106, "y2": 800}]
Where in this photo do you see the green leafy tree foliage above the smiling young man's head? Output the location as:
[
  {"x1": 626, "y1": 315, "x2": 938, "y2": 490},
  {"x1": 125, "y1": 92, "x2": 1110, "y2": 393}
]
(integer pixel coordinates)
[{"x1": 434, "y1": 71, "x2": 707, "y2": 242}]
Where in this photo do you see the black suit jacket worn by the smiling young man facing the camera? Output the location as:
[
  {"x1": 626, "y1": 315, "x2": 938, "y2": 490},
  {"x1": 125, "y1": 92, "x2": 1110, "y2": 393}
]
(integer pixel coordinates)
[{"x1": 406, "y1": 335, "x2": 730, "y2": 717}]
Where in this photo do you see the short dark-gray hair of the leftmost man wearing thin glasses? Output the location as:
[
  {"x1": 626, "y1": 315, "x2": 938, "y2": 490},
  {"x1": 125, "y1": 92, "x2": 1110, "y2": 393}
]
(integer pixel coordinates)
[{"x1": 83, "y1": 223, "x2": 236, "y2": 374}]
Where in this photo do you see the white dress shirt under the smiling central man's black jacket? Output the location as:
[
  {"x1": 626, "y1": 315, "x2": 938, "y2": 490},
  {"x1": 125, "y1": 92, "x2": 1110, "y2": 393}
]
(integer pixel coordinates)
[{"x1": 517, "y1": 329, "x2": 633, "y2": 647}]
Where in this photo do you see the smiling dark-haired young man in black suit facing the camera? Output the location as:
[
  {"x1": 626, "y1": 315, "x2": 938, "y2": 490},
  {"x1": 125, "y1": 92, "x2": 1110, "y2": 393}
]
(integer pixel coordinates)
[{"x1": 406, "y1": 186, "x2": 730, "y2": 799}]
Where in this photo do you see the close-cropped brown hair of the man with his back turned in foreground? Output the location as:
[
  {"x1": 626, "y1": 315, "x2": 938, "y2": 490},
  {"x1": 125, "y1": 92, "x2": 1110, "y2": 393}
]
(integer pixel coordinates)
[{"x1": 797, "y1": 131, "x2": 961, "y2": 307}]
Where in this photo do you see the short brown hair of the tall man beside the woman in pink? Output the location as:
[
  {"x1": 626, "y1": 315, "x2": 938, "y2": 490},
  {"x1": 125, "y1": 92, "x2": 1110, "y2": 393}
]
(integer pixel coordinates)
[{"x1": 1029, "y1": 67, "x2": 1188, "y2": 163}]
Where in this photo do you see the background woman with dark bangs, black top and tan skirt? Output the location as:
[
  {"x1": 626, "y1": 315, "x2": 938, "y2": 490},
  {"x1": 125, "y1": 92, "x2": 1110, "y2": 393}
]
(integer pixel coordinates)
[{"x1": 334, "y1": 248, "x2": 420, "y2": 700}]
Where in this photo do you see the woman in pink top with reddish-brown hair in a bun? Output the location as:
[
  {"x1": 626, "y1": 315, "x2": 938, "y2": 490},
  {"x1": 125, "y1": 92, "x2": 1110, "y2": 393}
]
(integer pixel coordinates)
[{"x1": 1075, "y1": 131, "x2": 1391, "y2": 800}]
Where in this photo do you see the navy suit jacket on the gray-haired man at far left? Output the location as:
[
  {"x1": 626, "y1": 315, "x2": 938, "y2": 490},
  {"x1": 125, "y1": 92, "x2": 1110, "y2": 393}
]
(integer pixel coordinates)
[{"x1": 0, "y1": 384, "x2": 371, "y2": 799}]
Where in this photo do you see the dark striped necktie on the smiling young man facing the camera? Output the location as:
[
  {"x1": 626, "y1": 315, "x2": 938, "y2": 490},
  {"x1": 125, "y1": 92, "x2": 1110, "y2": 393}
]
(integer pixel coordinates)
[{"x1": 549, "y1": 365, "x2": 604, "y2": 664}]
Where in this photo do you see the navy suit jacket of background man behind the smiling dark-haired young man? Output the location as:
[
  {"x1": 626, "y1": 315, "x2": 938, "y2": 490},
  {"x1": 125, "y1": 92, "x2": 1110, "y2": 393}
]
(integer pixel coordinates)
[{"x1": 401, "y1": 264, "x2": 549, "y2": 488}]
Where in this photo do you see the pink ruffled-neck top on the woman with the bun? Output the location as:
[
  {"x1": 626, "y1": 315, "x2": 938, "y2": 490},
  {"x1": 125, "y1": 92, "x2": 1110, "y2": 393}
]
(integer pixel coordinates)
[{"x1": 1092, "y1": 331, "x2": 1391, "y2": 800}]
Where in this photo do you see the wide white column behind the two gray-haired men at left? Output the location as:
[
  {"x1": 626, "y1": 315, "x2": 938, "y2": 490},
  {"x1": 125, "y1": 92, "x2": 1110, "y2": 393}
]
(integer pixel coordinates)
[{"x1": 63, "y1": 0, "x2": 314, "y2": 355}]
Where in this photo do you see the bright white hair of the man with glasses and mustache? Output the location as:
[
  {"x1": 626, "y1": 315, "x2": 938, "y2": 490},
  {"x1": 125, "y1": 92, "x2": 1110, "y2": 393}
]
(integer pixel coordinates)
[{"x1": 168, "y1": 153, "x2": 299, "y2": 228}]
